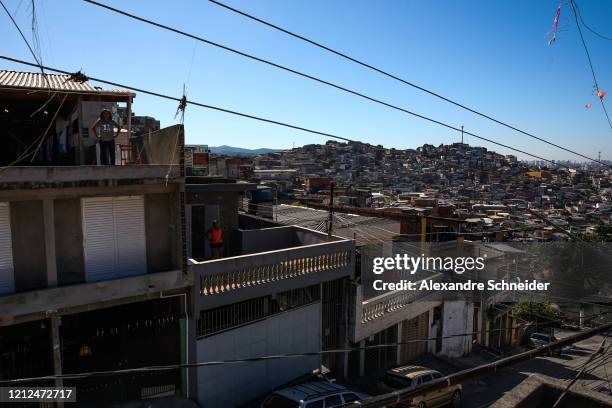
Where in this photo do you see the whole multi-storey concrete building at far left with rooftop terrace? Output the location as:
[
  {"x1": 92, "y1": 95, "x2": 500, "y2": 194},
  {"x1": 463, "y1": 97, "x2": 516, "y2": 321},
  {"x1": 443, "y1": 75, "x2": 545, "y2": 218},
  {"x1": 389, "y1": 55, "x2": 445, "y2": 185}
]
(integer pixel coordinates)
[{"x1": 0, "y1": 73, "x2": 195, "y2": 406}]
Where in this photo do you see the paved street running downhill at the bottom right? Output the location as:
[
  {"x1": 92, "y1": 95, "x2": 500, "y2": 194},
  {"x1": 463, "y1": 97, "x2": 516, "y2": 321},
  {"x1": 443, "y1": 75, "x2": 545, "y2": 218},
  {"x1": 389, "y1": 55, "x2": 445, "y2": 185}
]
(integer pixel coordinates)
[{"x1": 463, "y1": 332, "x2": 612, "y2": 408}]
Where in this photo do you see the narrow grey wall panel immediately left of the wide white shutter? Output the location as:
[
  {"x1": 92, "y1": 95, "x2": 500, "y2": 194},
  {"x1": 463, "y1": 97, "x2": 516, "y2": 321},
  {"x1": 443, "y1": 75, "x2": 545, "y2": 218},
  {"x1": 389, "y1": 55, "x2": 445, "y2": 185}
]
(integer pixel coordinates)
[{"x1": 54, "y1": 198, "x2": 85, "y2": 285}]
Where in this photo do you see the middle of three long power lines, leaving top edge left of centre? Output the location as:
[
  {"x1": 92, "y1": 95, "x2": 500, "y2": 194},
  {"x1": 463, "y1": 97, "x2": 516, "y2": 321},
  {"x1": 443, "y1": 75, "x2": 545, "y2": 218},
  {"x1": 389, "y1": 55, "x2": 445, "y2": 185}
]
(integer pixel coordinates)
[{"x1": 83, "y1": 0, "x2": 612, "y2": 167}]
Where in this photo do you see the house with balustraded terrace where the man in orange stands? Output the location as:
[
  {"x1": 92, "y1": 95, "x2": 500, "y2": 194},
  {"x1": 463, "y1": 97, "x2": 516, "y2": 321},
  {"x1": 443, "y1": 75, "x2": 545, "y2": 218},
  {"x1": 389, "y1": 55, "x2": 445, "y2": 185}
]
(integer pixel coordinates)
[{"x1": 186, "y1": 178, "x2": 355, "y2": 408}]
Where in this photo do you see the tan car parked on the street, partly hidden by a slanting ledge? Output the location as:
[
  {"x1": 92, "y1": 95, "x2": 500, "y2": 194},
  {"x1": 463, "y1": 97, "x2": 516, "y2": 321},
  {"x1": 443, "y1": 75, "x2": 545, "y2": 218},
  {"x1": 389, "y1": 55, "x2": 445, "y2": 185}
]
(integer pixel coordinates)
[{"x1": 379, "y1": 366, "x2": 463, "y2": 408}]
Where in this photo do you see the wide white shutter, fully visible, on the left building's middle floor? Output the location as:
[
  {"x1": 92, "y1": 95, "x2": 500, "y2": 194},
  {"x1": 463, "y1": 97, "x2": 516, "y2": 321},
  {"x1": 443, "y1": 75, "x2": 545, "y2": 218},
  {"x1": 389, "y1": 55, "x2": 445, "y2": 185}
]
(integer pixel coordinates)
[{"x1": 82, "y1": 196, "x2": 147, "y2": 282}]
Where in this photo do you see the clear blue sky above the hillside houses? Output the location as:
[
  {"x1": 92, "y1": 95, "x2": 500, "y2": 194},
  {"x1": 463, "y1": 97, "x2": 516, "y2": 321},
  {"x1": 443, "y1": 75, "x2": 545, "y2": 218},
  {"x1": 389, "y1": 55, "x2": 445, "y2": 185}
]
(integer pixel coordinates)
[{"x1": 0, "y1": 0, "x2": 612, "y2": 160}]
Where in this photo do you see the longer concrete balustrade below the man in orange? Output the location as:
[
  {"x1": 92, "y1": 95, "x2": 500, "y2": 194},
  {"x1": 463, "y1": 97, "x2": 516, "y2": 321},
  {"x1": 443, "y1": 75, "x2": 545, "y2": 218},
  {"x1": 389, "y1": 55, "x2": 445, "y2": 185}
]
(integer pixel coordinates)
[{"x1": 192, "y1": 240, "x2": 354, "y2": 296}]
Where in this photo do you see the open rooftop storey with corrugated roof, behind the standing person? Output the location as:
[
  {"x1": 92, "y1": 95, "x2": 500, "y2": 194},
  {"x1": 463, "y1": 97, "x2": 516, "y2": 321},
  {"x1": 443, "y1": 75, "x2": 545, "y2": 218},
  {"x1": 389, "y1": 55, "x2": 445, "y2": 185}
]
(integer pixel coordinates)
[{"x1": 0, "y1": 70, "x2": 135, "y2": 165}]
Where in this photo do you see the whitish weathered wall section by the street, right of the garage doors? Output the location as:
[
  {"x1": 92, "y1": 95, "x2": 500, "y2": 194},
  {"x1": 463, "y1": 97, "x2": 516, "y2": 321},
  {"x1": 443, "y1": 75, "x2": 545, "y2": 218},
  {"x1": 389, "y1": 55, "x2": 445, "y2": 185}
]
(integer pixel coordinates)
[{"x1": 440, "y1": 300, "x2": 474, "y2": 357}]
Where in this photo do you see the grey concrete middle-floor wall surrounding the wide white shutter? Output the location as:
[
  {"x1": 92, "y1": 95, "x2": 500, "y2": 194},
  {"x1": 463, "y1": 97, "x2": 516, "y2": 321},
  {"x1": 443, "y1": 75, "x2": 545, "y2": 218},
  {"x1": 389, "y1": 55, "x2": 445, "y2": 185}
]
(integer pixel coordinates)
[{"x1": 4, "y1": 185, "x2": 182, "y2": 292}]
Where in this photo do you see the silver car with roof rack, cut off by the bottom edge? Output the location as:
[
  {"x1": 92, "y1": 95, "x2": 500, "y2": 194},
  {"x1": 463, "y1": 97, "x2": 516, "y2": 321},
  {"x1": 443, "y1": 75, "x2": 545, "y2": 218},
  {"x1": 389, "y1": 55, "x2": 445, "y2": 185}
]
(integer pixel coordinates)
[{"x1": 261, "y1": 381, "x2": 369, "y2": 408}]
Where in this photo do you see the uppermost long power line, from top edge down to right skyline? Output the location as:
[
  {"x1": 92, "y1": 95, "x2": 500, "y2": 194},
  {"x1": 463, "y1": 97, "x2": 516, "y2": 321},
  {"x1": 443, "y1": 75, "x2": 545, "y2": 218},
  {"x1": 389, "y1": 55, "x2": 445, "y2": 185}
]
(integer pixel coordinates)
[{"x1": 208, "y1": 0, "x2": 607, "y2": 166}]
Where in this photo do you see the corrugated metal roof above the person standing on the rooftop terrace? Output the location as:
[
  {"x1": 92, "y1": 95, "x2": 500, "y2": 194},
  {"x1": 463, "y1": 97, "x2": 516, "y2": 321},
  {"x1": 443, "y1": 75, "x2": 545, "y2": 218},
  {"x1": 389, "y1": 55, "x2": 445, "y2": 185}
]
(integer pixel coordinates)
[{"x1": 0, "y1": 70, "x2": 134, "y2": 95}]
